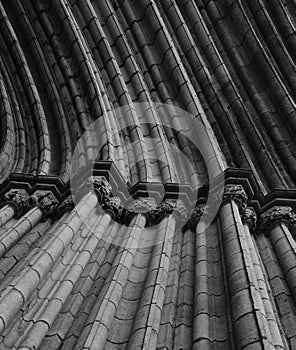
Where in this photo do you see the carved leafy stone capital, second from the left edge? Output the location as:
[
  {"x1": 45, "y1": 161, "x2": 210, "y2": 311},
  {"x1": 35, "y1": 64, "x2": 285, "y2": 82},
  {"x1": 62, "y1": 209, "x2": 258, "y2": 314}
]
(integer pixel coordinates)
[{"x1": 29, "y1": 191, "x2": 58, "y2": 219}]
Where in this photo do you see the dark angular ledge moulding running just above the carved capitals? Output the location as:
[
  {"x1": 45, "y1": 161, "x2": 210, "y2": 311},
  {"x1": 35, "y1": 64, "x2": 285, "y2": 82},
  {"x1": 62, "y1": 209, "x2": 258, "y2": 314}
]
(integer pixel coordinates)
[{"x1": 0, "y1": 161, "x2": 296, "y2": 216}]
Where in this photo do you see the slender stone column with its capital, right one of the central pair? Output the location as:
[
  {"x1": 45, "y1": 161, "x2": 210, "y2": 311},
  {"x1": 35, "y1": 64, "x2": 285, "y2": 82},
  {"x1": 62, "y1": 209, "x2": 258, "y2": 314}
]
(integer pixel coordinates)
[{"x1": 128, "y1": 200, "x2": 187, "y2": 350}]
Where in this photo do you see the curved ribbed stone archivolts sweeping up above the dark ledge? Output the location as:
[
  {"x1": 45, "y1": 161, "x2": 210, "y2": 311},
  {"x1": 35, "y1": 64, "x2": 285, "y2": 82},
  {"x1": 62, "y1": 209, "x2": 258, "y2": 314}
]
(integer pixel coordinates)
[{"x1": 0, "y1": 0, "x2": 296, "y2": 191}]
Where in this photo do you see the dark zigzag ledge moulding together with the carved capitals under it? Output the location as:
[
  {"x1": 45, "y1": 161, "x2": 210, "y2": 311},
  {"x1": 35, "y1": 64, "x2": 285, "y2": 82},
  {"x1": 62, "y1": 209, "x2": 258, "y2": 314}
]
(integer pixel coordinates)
[{"x1": 0, "y1": 161, "x2": 296, "y2": 232}]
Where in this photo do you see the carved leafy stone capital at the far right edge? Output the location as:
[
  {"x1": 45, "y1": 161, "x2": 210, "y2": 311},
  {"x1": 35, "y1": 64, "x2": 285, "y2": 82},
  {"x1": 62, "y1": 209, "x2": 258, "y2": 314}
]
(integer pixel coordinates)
[{"x1": 258, "y1": 206, "x2": 296, "y2": 233}]
